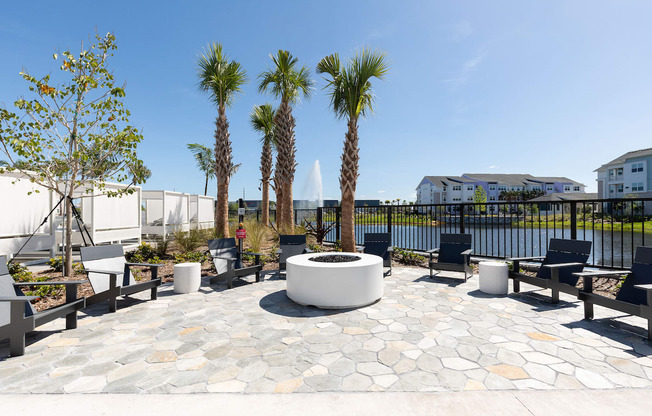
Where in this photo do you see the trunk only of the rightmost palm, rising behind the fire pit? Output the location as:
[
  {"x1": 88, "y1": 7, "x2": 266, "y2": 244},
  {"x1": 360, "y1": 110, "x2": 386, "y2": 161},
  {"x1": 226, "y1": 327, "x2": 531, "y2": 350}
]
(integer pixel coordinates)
[{"x1": 340, "y1": 118, "x2": 360, "y2": 253}]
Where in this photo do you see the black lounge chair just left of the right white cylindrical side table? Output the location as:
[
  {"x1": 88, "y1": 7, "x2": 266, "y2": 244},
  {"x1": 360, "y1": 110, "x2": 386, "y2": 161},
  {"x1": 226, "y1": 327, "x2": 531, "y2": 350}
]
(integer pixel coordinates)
[{"x1": 427, "y1": 234, "x2": 473, "y2": 282}]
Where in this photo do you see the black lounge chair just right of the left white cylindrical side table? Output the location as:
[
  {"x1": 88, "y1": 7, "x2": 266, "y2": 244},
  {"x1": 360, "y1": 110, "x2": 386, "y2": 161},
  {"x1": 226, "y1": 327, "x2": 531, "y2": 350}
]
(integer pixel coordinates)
[{"x1": 208, "y1": 238, "x2": 263, "y2": 289}]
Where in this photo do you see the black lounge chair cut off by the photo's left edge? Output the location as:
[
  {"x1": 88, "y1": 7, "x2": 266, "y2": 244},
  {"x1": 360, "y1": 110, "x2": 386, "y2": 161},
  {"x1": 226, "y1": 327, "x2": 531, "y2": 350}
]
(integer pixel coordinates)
[{"x1": 0, "y1": 256, "x2": 86, "y2": 356}]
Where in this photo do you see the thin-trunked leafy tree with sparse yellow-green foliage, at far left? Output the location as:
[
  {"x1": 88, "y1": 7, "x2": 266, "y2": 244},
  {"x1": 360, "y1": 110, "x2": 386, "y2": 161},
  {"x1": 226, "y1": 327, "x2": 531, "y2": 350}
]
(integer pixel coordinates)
[{"x1": 0, "y1": 33, "x2": 151, "y2": 275}]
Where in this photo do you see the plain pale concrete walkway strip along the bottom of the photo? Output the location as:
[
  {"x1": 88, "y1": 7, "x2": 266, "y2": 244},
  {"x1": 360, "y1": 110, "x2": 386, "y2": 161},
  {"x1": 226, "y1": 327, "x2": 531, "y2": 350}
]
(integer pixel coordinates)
[{"x1": 0, "y1": 389, "x2": 652, "y2": 416}]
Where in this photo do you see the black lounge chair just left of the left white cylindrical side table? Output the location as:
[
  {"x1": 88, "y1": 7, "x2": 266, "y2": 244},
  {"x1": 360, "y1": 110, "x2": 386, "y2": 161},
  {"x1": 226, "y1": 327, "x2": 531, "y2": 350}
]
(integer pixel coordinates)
[{"x1": 79, "y1": 244, "x2": 163, "y2": 312}]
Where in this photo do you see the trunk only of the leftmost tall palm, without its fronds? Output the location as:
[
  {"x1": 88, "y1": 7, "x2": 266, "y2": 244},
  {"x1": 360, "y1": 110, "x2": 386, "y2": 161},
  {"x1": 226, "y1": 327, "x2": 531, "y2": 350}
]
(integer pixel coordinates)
[{"x1": 215, "y1": 106, "x2": 233, "y2": 238}]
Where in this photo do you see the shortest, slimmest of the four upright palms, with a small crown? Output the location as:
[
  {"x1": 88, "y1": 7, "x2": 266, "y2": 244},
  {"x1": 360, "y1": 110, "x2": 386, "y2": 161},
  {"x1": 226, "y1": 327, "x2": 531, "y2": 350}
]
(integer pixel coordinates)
[{"x1": 250, "y1": 104, "x2": 276, "y2": 225}]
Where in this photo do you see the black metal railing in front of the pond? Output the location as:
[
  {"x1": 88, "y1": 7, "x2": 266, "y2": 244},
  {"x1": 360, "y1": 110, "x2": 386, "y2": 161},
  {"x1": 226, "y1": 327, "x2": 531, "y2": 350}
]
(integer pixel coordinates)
[{"x1": 315, "y1": 198, "x2": 652, "y2": 268}]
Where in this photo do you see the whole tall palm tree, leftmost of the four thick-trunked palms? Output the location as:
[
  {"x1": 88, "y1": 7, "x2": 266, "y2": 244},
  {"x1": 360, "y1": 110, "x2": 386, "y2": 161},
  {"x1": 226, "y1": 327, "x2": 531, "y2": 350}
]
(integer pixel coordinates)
[{"x1": 197, "y1": 43, "x2": 247, "y2": 237}]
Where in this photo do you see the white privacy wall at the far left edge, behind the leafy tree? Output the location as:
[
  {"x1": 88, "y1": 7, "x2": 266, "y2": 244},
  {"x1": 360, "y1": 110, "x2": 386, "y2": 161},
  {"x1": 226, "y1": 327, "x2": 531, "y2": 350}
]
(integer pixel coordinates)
[{"x1": 0, "y1": 172, "x2": 58, "y2": 256}]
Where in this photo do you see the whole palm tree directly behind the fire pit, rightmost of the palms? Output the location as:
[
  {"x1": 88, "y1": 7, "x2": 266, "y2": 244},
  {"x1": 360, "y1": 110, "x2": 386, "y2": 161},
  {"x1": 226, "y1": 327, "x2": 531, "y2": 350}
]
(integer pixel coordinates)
[{"x1": 317, "y1": 49, "x2": 389, "y2": 252}]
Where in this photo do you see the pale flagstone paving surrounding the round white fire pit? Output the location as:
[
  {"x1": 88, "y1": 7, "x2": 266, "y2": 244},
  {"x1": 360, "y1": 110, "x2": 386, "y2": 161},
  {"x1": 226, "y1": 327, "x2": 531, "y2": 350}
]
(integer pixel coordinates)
[{"x1": 0, "y1": 268, "x2": 652, "y2": 393}]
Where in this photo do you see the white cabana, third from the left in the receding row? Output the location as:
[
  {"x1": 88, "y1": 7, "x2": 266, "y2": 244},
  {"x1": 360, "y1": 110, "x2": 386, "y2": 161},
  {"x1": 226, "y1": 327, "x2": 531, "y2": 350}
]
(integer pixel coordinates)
[{"x1": 142, "y1": 191, "x2": 190, "y2": 239}]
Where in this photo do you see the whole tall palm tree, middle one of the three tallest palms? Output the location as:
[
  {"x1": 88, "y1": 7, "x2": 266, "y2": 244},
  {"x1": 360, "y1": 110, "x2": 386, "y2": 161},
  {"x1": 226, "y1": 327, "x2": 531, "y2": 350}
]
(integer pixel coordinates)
[{"x1": 258, "y1": 50, "x2": 313, "y2": 233}]
